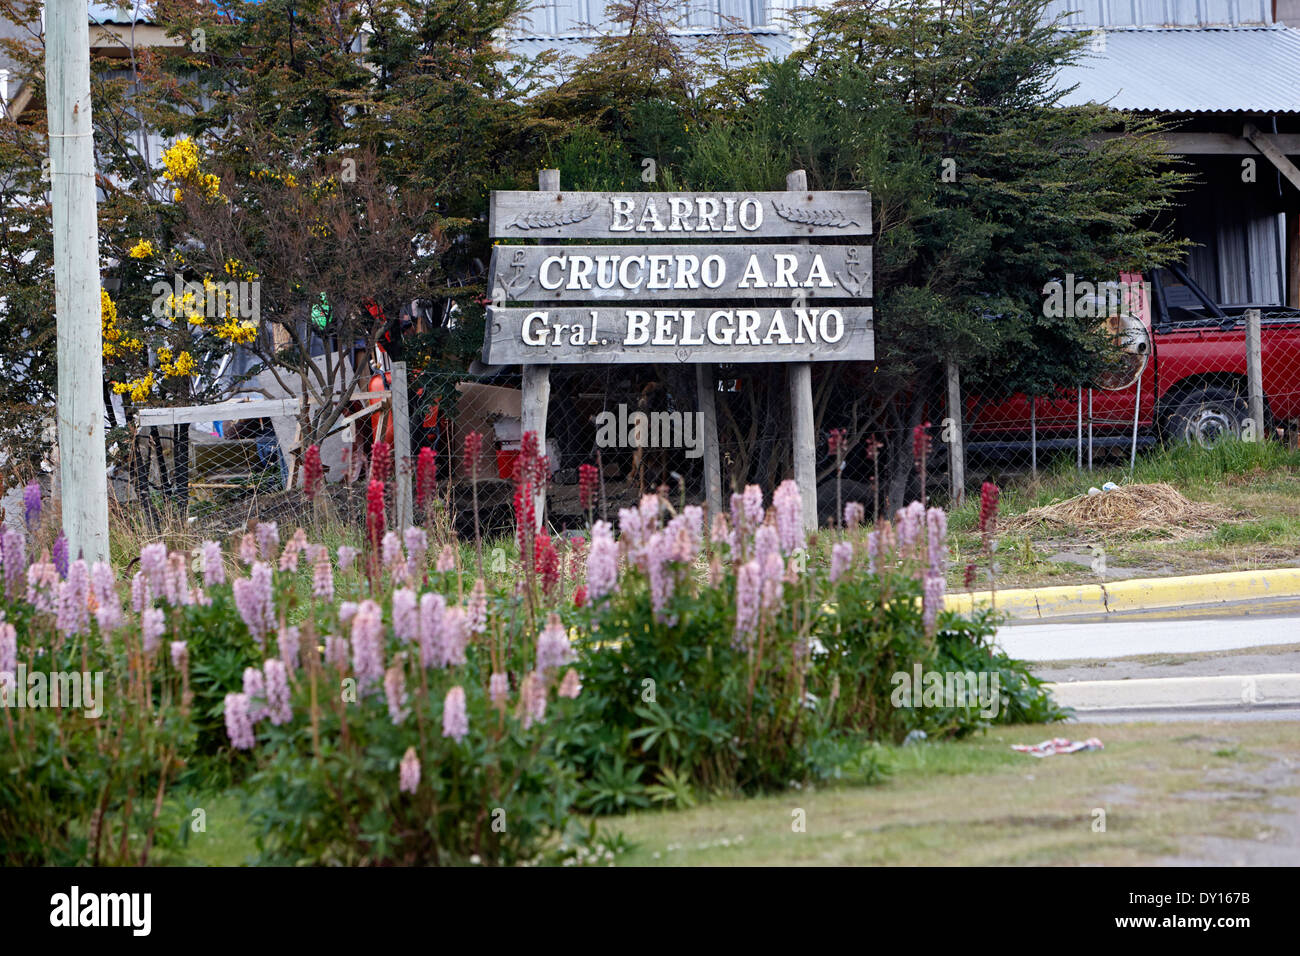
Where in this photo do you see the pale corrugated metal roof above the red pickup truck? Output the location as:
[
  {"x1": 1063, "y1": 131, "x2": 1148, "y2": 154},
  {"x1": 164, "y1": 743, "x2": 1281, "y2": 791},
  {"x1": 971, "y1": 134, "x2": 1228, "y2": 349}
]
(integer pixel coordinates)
[{"x1": 1057, "y1": 26, "x2": 1300, "y2": 113}]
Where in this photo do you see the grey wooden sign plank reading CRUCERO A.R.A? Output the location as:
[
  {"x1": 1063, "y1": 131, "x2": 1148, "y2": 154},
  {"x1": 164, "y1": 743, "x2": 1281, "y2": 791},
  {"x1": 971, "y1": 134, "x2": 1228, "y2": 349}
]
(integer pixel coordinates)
[{"x1": 489, "y1": 243, "x2": 871, "y2": 304}]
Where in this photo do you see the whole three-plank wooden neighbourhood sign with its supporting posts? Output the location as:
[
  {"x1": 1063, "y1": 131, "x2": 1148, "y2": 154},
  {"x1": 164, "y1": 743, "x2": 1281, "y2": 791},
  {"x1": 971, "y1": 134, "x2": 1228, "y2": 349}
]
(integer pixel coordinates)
[{"x1": 482, "y1": 169, "x2": 875, "y2": 529}]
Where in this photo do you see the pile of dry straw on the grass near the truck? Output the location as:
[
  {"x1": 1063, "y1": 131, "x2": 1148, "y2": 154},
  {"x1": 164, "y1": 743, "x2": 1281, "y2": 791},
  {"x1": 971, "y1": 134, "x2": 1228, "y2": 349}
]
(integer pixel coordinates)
[{"x1": 998, "y1": 481, "x2": 1232, "y2": 538}]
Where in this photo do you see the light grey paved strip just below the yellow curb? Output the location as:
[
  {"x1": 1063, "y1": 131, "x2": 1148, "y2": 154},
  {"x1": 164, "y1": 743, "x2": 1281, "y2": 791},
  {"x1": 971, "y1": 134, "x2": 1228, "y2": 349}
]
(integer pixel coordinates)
[{"x1": 996, "y1": 614, "x2": 1300, "y2": 661}]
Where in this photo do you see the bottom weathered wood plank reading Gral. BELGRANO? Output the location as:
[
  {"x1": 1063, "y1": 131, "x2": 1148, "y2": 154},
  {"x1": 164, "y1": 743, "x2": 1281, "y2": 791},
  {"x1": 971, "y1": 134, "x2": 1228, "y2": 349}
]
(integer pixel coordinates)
[{"x1": 484, "y1": 304, "x2": 875, "y2": 365}]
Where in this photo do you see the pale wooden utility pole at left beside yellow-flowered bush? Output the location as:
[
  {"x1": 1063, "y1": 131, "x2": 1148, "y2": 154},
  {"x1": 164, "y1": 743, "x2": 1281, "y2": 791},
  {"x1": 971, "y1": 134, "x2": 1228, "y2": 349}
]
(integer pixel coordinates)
[{"x1": 46, "y1": 0, "x2": 108, "y2": 562}]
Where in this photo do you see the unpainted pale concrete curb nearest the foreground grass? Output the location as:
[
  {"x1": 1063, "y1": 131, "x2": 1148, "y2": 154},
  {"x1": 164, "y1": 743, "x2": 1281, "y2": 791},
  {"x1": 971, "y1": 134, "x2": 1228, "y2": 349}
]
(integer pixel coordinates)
[{"x1": 1044, "y1": 674, "x2": 1300, "y2": 711}]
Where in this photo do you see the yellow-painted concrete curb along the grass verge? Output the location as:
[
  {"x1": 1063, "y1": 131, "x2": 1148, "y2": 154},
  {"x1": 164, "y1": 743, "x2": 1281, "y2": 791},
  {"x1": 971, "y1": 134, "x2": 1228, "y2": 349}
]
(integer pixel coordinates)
[{"x1": 945, "y1": 567, "x2": 1300, "y2": 620}]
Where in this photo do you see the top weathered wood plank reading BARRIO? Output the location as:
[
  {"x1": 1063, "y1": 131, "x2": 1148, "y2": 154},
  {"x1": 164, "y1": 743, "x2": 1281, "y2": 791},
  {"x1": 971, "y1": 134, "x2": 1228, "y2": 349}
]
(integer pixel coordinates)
[{"x1": 489, "y1": 190, "x2": 871, "y2": 241}]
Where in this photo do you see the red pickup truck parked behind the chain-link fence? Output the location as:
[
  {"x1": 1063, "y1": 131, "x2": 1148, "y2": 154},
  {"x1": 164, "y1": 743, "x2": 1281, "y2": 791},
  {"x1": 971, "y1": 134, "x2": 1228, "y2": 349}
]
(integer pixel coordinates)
[{"x1": 966, "y1": 267, "x2": 1300, "y2": 454}]
